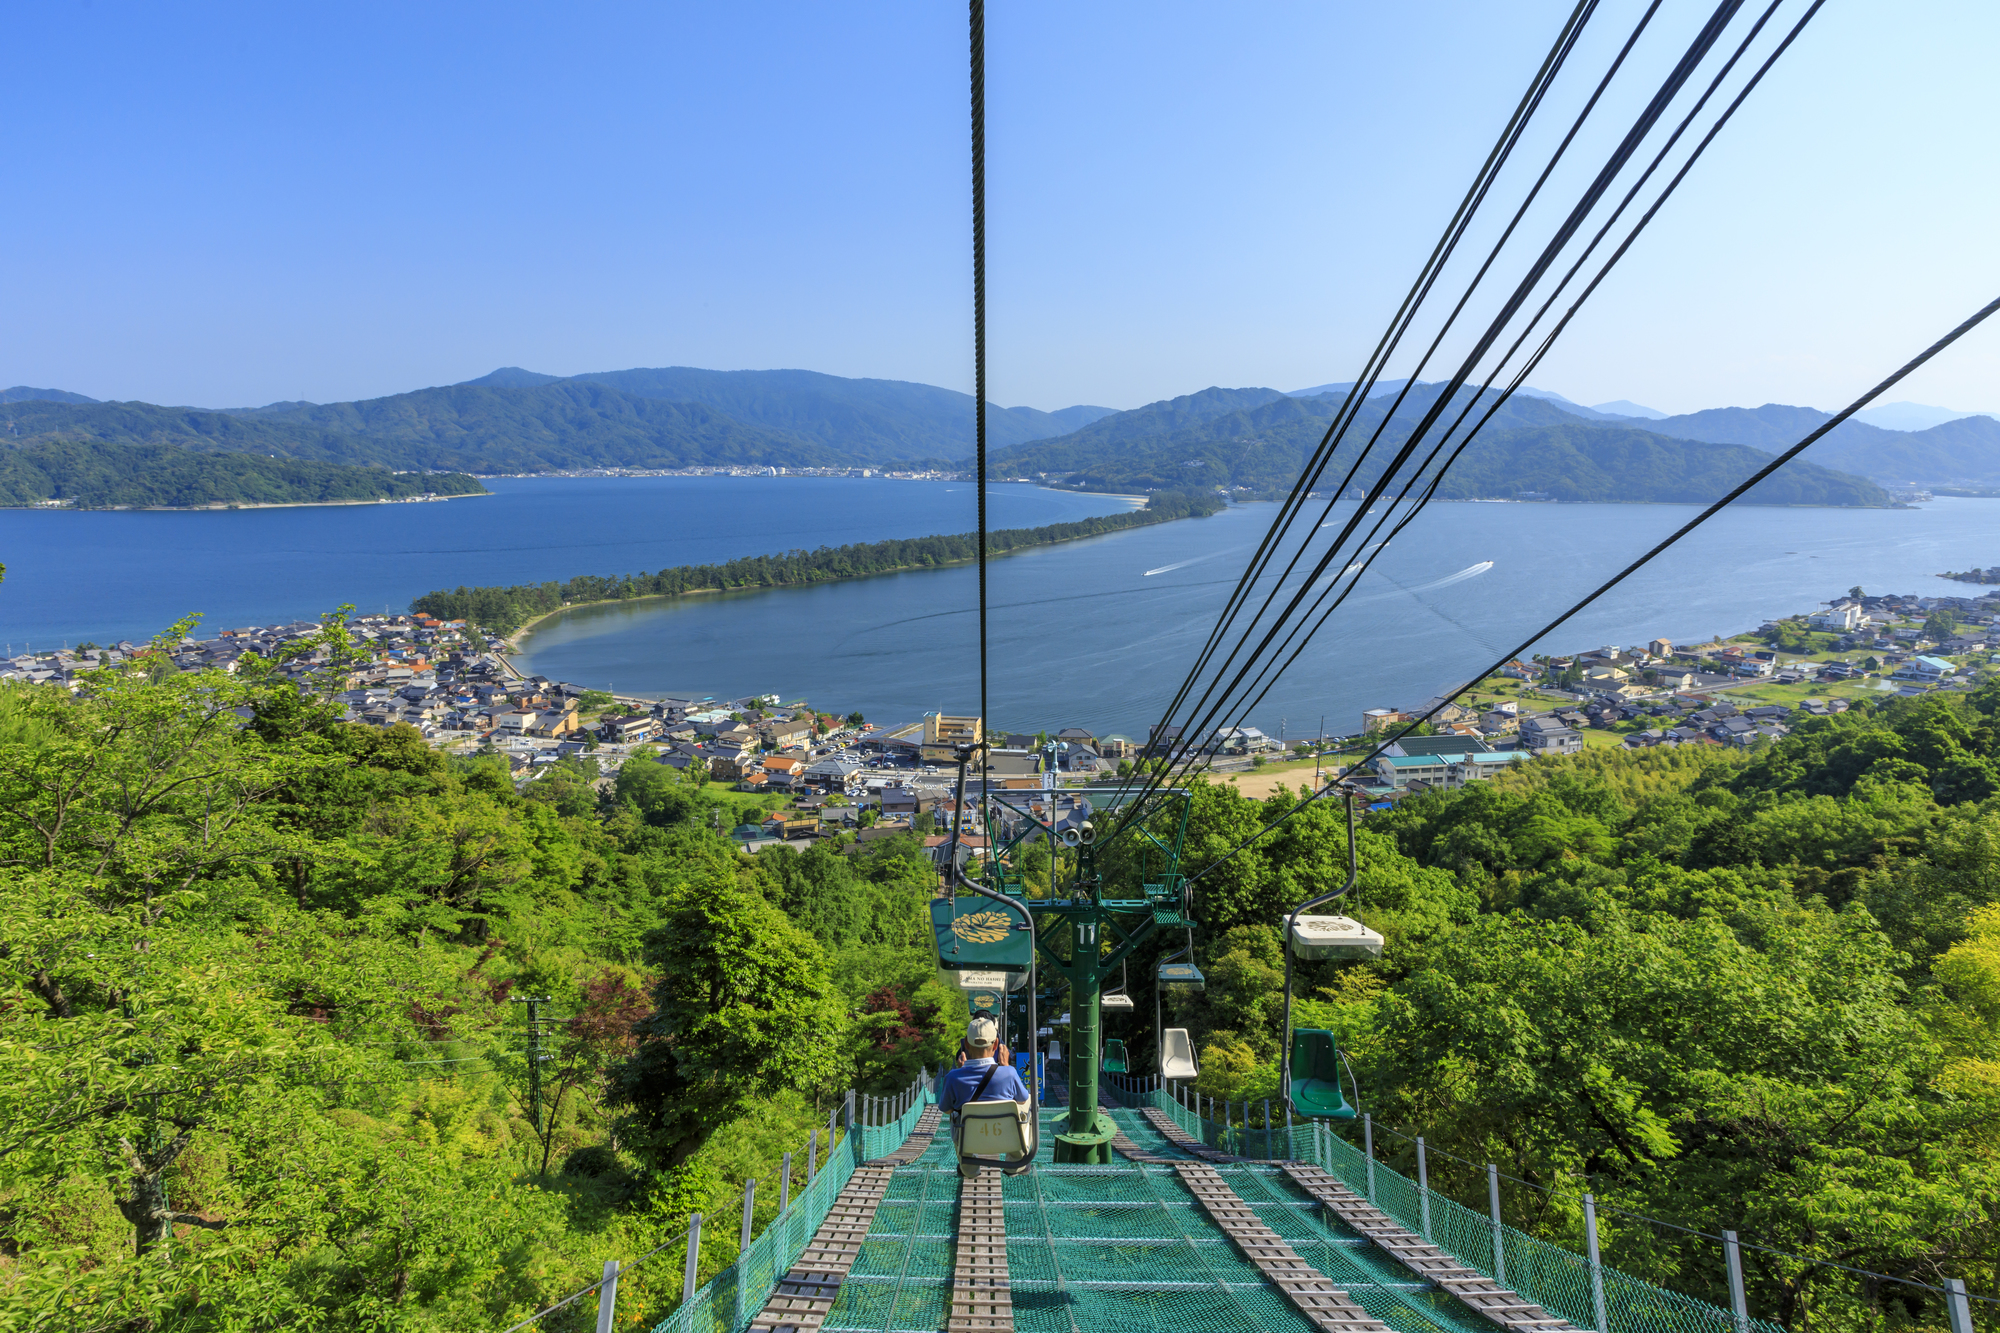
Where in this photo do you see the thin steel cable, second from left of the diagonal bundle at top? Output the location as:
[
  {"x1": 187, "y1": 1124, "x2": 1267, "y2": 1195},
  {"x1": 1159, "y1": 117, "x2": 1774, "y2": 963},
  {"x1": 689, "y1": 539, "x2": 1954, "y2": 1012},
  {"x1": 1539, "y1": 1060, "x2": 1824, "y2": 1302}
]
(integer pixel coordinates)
[{"x1": 1128, "y1": 0, "x2": 1662, "y2": 804}]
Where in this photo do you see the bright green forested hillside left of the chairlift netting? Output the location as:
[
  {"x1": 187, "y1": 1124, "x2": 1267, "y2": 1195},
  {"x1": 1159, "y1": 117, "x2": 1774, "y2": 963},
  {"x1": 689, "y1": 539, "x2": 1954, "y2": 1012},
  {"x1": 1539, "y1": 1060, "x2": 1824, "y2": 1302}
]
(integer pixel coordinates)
[{"x1": 0, "y1": 626, "x2": 962, "y2": 1333}]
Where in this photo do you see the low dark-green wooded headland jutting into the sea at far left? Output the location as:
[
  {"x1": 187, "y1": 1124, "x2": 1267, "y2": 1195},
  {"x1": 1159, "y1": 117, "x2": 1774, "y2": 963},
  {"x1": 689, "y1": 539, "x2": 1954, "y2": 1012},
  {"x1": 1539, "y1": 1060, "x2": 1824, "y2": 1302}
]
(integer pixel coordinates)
[{"x1": 0, "y1": 438, "x2": 488, "y2": 508}]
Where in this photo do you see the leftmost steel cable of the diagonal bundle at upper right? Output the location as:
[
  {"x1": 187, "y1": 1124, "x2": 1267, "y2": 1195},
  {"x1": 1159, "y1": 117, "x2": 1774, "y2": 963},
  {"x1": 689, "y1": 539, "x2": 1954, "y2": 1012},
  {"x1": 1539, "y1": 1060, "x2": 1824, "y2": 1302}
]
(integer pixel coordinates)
[{"x1": 1146, "y1": 0, "x2": 1596, "y2": 808}]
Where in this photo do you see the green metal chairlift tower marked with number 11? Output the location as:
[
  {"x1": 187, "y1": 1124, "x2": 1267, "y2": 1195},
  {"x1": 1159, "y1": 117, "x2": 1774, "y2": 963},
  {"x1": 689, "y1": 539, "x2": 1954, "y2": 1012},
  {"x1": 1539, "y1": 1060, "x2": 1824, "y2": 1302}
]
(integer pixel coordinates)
[{"x1": 930, "y1": 751, "x2": 1196, "y2": 1165}]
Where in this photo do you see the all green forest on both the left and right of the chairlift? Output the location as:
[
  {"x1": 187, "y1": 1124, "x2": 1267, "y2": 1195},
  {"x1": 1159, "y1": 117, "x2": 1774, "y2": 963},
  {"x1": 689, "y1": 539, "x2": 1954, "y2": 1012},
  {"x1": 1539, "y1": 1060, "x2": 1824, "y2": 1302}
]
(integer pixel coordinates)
[{"x1": 0, "y1": 622, "x2": 2000, "y2": 1333}]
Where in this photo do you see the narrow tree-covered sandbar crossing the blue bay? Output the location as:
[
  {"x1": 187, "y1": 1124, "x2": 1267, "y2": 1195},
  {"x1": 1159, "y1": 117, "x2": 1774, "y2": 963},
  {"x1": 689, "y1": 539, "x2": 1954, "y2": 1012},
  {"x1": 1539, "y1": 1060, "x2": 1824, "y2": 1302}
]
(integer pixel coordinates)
[{"x1": 410, "y1": 490, "x2": 1224, "y2": 634}]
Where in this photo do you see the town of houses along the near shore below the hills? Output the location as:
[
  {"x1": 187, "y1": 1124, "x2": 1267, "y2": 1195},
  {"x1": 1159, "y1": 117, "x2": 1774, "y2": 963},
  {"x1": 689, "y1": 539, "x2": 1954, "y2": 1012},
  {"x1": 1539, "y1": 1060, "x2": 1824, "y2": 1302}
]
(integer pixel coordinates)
[{"x1": 0, "y1": 588, "x2": 2000, "y2": 840}]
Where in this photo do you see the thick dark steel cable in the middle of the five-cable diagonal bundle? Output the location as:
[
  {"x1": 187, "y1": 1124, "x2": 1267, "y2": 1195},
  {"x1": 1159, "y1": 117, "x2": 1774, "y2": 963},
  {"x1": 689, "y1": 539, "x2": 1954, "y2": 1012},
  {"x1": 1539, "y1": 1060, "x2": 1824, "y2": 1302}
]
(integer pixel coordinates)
[{"x1": 1144, "y1": 0, "x2": 1744, "y2": 808}]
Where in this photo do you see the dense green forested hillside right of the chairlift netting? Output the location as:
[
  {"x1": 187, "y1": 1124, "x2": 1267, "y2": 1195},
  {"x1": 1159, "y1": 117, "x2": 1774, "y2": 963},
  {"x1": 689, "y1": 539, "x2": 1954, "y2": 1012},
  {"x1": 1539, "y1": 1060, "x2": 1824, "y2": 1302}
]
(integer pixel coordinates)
[{"x1": 1182, "y1": 685, "x2": 2000, "y2": 1329}]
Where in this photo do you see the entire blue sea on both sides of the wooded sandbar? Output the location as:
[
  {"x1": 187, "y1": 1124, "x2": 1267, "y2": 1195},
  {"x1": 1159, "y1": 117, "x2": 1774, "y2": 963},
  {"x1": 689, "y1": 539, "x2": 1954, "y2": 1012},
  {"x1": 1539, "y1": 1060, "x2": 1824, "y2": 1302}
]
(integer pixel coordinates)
[{"x1": 0, "y1": 476, "x2": 2000, "y2": 737}]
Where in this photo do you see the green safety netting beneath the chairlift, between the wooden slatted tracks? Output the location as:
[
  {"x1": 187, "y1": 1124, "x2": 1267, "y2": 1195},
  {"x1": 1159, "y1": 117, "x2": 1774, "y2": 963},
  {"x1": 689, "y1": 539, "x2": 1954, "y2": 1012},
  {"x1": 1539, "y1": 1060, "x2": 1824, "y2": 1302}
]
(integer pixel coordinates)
[{"x1": 654, "y1": 1081, "x2": 1782, "y2": 1333}]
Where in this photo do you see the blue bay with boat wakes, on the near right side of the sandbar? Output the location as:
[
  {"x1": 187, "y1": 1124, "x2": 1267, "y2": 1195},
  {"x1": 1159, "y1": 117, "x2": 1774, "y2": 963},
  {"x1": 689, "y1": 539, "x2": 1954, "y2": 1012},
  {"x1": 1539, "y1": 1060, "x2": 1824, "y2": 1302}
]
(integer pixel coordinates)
[{"x1": 520, "y1": 500, "x2": 2000, "y2": 739}]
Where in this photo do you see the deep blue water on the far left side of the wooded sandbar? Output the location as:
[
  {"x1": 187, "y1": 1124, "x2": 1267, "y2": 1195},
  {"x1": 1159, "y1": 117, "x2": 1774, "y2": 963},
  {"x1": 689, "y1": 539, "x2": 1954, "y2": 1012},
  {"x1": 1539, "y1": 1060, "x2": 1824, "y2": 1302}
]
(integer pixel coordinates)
[{"x1": 0, "y1": 476, "x2": 1130, "y2": 650}]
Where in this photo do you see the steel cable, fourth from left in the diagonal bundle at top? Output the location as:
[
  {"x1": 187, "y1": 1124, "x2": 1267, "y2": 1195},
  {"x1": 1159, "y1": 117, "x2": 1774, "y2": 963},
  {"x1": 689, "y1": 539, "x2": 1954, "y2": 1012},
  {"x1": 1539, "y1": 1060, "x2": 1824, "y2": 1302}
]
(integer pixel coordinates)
[{"x1": 1176, "y1": 0, "x2": 1824, "y2": 752}]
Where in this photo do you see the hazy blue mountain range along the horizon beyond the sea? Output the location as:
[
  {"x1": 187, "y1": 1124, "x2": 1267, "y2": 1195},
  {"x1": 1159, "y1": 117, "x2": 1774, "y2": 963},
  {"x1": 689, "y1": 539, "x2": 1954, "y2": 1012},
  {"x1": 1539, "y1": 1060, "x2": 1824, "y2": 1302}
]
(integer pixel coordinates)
[{"x1": 11, "y1": 366, "x2": 2000, "y2": 504}]
